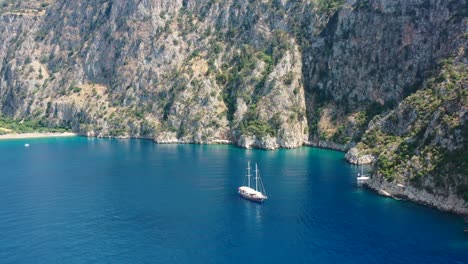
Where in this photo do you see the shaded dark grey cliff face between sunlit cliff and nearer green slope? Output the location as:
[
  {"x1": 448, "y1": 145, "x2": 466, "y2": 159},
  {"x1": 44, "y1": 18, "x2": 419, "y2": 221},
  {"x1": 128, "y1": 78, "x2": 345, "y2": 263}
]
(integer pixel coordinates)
[{"x1": 303, "y1": 0, "x2": 466, "y2": 149}]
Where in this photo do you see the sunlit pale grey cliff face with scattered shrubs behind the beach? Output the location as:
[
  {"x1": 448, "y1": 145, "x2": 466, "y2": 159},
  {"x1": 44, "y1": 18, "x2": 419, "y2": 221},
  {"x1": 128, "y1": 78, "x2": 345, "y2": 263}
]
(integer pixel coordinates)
[{"x1": 0, "y1": 1, "x2": 307, "y2": 148}]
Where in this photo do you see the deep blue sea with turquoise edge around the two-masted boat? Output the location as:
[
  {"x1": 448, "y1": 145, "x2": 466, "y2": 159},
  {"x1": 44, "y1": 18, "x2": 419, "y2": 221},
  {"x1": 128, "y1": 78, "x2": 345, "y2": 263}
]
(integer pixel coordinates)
[{"x1": 0, "y1": 137, "x2": 468, "y2": 264}]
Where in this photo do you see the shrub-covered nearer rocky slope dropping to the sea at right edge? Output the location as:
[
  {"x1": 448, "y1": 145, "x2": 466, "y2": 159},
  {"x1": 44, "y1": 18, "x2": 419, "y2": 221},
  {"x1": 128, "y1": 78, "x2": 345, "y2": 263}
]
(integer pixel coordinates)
[{"x1": 353, "y1": 56, "x2": 468, "y2": 213}]
